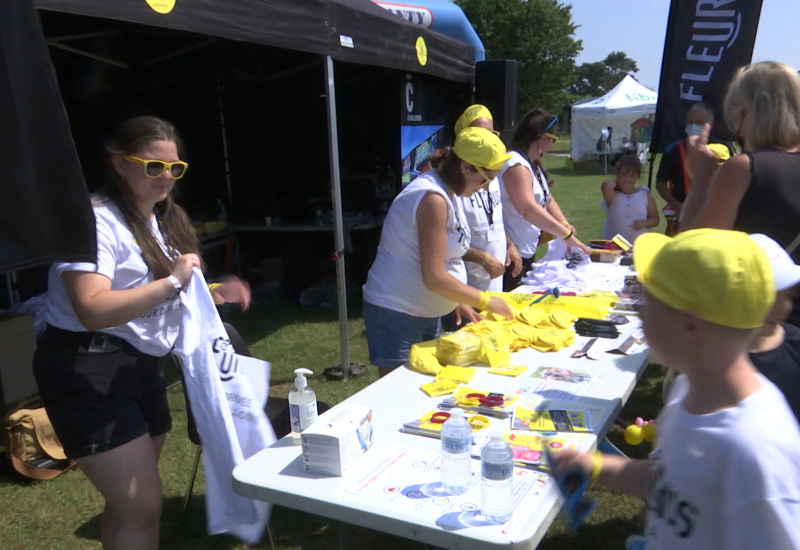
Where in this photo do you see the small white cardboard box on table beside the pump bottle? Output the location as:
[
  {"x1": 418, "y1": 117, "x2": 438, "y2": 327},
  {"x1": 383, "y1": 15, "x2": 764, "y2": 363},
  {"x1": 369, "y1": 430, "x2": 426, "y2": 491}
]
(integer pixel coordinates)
[{"x1": 300, "y1": 405, "x2": 372, "y2": 476}]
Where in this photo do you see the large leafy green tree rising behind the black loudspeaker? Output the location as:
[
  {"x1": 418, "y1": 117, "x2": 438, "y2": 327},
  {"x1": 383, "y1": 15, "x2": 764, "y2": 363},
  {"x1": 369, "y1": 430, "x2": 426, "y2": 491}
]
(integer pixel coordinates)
[{"x1": 456, "y1": 0, "x2": 582, "y2": 114}]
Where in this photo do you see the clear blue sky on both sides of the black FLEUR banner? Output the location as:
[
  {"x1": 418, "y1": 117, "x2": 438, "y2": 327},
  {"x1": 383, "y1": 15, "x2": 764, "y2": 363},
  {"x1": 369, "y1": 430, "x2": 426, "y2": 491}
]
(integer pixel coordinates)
[{"x1": 562, "y1": 0, "x2": 800, "y2": 90}]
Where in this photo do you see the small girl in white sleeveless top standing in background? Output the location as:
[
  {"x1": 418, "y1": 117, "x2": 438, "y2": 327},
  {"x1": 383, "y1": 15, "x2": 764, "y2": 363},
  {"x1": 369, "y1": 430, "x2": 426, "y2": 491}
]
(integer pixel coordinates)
[{"x1": 600, "y1": 155, "x2": 659, "y2": 242}]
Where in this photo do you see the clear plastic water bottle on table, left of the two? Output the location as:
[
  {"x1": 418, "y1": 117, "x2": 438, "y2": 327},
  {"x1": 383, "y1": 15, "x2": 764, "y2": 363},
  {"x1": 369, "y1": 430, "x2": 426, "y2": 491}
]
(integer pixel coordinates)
[{"x1": 442, "y1": 408, "x2": 472, "y2": 495}]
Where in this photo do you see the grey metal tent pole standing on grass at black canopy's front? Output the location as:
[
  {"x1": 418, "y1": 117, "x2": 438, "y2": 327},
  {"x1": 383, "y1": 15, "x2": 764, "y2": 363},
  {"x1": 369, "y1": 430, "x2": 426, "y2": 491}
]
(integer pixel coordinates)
[{"x1": 325, "y1": 55, "x2": 350, "y2": 380}]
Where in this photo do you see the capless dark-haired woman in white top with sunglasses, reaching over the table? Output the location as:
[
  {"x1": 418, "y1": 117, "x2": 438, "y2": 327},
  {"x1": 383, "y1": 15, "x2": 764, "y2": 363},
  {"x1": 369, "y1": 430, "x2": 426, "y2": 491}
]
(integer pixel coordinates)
[{"x1": 498, "y1": 109, "x2": 588, "y2": 291}]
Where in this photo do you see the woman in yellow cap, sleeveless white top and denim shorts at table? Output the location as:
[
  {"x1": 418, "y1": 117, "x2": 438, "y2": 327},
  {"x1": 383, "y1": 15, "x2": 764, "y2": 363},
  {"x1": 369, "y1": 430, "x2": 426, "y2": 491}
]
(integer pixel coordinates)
[{"x1": 363, "y1": 128, "x2": 511, "y2": 376}]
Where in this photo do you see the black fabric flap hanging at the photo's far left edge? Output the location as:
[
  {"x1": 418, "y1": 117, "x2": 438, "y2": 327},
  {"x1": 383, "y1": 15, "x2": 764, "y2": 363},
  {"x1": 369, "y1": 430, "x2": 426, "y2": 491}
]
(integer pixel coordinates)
[{"x1": 0, "y1": 1, "x2": 96, "y2": 271}]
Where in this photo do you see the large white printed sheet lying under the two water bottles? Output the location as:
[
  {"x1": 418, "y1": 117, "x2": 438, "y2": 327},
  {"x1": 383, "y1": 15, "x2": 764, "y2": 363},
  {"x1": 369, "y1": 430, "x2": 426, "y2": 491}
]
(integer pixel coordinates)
[{"x1": 340, "y1": 445, "x2": 553, "y2": 534}]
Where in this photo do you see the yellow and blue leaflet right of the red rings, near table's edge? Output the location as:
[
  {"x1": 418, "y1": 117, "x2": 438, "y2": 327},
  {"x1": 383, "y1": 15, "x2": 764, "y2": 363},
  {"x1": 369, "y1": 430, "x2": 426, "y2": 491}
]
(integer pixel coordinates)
[{"x1": 511, "y1": 399, "x2": 603, "y2": 432}]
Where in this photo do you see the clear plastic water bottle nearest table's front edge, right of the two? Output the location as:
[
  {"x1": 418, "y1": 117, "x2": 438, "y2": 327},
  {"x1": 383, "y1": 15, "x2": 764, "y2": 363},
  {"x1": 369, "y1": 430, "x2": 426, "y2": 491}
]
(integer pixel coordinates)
[{"x1": 481, "y1": 426, "x2": 514, "y2": 523}]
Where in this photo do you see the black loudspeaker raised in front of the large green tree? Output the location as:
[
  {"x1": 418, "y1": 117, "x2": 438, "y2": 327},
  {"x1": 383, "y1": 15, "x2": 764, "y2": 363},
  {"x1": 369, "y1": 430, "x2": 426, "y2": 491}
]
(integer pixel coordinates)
[{"x1": 475, "y1": 59, "x2": 520, "y2": 132}]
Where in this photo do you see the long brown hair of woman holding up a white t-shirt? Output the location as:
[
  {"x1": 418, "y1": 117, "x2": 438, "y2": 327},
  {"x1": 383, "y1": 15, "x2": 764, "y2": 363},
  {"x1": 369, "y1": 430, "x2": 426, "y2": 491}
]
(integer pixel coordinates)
[{"x1": 99, "y1": 116, "x2": 200, "y2": 279}]
